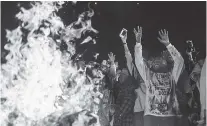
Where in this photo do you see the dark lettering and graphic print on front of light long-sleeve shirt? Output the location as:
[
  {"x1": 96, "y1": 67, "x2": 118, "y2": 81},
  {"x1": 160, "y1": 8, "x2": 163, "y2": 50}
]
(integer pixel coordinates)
[{"x1": 147, "y1": 72, "x2": 174, "y2": 115}]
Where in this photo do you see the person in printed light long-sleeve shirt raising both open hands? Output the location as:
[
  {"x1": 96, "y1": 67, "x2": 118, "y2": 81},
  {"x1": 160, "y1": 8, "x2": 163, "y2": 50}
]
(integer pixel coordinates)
[{"x1": 134, "y1": 27, "x2": 184, "y2": 126}]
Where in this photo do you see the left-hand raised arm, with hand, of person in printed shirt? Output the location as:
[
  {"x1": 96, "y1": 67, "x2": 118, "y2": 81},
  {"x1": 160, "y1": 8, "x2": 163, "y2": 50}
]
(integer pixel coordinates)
[{"x1": 134, "y1": 26, "x2": 148, "y2": 82}]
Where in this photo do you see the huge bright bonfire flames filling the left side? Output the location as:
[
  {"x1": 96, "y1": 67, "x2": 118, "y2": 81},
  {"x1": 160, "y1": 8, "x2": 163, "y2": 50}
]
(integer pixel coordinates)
[{"x1": 0, "y1": 1, "x2": 104, "y2": 126}]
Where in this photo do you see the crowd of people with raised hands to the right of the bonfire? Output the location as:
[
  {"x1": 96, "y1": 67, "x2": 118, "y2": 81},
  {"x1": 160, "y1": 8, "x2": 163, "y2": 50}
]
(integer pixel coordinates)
[{"x1": 81, "y1": 27, "x2": 206, "y2": 126}]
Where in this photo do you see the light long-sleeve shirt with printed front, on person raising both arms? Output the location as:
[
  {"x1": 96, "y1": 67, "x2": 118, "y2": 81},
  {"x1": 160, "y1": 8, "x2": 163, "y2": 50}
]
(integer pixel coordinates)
[{"x1": 135, "y1": 43, "x2": 184, "y2": 116}]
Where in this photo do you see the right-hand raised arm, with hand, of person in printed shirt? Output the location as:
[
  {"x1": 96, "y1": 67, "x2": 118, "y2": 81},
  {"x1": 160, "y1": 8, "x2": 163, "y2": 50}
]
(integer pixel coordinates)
[{"x1": 158, "y1": 29, "x2": 184, "y2": 83}]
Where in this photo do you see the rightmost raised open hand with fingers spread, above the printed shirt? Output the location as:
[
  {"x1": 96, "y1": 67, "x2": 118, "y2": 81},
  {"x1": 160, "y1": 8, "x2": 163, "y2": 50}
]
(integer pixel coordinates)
[{"x1": 157, "y1": 29, "x2": 170, "y2": 46}]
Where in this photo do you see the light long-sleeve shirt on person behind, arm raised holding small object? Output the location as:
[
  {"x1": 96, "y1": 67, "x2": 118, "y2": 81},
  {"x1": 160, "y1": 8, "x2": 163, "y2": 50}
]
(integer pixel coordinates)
[{"x1": 124, "y1": 44, "x2": 146, "y2": 112}]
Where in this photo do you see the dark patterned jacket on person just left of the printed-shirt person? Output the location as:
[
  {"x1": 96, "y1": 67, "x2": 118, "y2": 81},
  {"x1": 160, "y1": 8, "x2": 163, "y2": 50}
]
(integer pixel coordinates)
[{"x1": 114, "y1": 72, "x2": 135, "y2": 126}]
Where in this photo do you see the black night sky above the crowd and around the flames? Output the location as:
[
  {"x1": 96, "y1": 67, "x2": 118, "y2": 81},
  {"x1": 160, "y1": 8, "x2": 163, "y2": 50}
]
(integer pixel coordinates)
[{"x1": 1, "y1": 2, "x2": 206, "y2": 67}]
